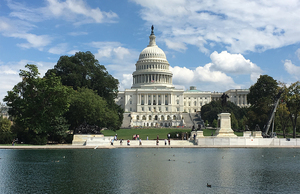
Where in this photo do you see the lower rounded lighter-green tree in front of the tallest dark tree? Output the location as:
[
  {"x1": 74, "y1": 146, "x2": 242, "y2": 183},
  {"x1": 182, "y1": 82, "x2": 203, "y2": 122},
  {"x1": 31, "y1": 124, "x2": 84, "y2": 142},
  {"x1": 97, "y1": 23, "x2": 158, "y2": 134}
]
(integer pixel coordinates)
[{"x1": 67, "y1": 88, "x2": 119, "y2": 133}]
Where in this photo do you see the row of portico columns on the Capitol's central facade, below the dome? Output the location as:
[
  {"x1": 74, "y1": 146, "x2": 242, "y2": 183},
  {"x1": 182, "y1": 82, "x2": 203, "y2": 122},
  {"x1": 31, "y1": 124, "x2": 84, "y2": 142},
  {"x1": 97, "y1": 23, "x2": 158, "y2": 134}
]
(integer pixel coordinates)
[{"x1": 137, "y1": 94, "x2": 171, "y2": 105}]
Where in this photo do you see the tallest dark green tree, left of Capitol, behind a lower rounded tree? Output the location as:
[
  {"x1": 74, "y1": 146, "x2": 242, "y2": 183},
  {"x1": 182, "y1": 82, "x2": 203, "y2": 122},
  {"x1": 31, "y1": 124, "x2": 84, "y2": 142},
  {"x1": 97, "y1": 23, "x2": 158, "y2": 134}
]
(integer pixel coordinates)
[{"x1": 46, "y1": 51, "x2": 124, "y2": 130}]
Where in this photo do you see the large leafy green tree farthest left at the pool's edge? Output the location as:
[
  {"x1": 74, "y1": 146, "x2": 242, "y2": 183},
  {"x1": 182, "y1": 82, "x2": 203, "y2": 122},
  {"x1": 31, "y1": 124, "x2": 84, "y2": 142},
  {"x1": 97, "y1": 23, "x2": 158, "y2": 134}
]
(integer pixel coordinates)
[{"x1": 4, "y1": 65, "x2": 70, "y2": 144}]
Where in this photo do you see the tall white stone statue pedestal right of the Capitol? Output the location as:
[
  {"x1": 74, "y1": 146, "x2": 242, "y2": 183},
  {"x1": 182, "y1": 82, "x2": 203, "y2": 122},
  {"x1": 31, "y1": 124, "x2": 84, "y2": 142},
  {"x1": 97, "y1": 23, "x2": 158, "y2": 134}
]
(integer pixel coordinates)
[{"x1": 215, "y1": 113, "x2": 237, "y2": 137}]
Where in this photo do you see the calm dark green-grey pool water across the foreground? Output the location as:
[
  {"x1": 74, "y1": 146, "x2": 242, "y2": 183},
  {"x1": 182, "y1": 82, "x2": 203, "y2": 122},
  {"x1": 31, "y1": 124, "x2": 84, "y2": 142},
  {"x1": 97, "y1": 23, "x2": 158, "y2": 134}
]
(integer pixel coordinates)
[{"x1": 0, "y1": 148, "x2": 300, "y2": 194}]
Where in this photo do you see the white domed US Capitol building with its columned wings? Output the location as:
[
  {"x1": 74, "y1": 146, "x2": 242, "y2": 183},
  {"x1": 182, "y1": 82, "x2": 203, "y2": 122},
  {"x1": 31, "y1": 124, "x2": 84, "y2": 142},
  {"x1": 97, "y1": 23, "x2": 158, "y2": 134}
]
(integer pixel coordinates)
[{"x1": 116, "y1": 26, "x2": 249, "y2": 127}]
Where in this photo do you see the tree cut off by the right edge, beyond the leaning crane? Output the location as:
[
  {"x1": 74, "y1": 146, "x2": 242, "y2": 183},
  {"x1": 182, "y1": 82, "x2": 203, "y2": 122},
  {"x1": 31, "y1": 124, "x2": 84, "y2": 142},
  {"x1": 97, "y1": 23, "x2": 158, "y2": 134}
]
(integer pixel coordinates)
[{"x1": 283, "y1": 81, "x2": 300, "y2": 138}]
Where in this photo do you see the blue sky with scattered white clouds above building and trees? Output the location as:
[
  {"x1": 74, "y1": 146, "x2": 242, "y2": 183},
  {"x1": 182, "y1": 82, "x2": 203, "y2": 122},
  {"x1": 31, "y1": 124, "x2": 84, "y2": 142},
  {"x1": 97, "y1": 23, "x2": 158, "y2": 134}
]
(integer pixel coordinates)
[{"x1": 0, "y1": 0, "x2": 300, "y2": 102}]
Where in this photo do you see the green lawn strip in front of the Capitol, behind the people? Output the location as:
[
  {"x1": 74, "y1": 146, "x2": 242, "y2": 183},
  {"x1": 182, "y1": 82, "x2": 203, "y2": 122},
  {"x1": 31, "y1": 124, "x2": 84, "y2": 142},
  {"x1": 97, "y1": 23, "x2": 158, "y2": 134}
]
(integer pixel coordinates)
[{"x1": 101, "y1": 128, "x2": 243, "y2": 139}]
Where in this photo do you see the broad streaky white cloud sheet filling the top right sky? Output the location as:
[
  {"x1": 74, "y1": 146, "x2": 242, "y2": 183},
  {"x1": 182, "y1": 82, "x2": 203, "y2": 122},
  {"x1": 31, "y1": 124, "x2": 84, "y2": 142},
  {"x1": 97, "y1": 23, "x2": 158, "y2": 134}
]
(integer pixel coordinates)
[{"x1": 131, "y1": 0, "x2": 300, "y2": 53}]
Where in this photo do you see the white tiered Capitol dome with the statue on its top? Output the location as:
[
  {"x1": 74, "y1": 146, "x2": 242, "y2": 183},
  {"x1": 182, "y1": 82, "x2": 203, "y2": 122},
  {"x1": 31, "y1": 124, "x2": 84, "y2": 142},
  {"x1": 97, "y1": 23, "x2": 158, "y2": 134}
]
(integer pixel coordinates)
[{"x1": 132, "y1": 27, "x2": 174, "y2": 88}]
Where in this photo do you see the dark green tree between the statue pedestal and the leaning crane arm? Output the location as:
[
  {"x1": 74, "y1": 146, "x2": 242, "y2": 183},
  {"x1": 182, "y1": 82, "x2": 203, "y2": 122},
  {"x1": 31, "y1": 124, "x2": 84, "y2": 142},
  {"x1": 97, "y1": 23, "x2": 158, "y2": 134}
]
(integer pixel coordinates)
[{"x1": 247, "y1": 75, "x2": 278, "y2": 130}]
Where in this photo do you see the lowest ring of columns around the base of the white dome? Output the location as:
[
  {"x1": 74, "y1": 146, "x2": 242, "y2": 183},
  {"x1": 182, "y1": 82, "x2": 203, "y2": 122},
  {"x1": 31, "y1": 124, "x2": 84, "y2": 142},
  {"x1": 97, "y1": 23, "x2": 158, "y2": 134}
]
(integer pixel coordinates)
[{"x1": 133, "y1": 74, "x2": 172, "y2": 84}]
